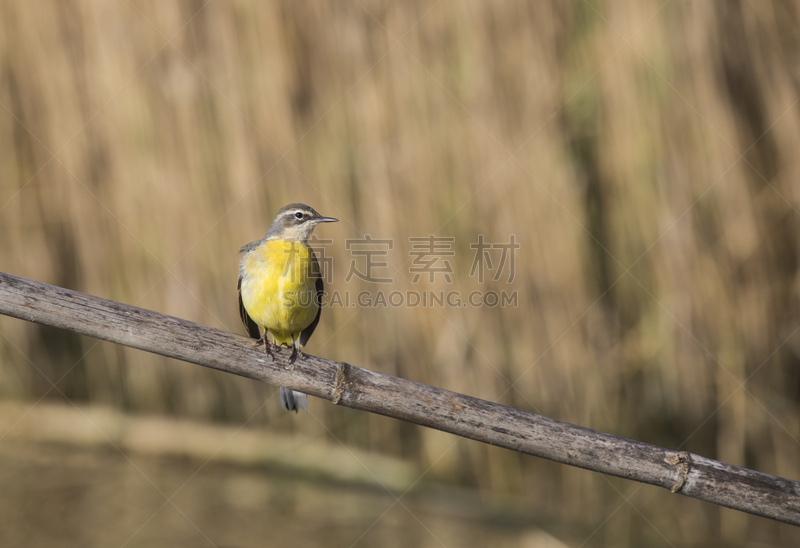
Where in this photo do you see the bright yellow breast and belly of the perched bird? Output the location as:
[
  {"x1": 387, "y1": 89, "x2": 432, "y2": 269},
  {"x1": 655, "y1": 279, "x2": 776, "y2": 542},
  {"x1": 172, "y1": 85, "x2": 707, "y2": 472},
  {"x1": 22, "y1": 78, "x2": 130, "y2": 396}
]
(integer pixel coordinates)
[{"x1": 241, "y1": 240, "x2": 319, "y2": 344}]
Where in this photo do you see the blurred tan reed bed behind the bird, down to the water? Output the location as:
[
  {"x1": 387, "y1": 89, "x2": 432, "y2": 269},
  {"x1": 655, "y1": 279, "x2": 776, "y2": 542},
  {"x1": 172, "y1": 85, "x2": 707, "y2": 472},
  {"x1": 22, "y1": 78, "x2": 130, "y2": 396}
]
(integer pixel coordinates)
[{"x1": 0, "y1": 0, "x2": 800, "y2": 546}]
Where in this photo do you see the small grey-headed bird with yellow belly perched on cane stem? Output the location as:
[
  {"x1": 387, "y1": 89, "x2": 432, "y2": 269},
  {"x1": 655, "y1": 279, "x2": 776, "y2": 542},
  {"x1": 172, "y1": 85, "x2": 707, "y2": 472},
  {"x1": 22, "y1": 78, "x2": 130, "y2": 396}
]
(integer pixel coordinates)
[{"x1": 238, "y1": 204, "x2": 338, "y2": 412}]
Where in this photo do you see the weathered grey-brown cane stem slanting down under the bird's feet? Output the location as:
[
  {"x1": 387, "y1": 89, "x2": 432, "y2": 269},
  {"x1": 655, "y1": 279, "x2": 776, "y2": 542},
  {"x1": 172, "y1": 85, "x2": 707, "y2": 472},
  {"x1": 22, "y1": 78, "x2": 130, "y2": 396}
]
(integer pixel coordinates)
[{"x1": 0, "y1": 272, "x2": 800, "y2": 525}]
